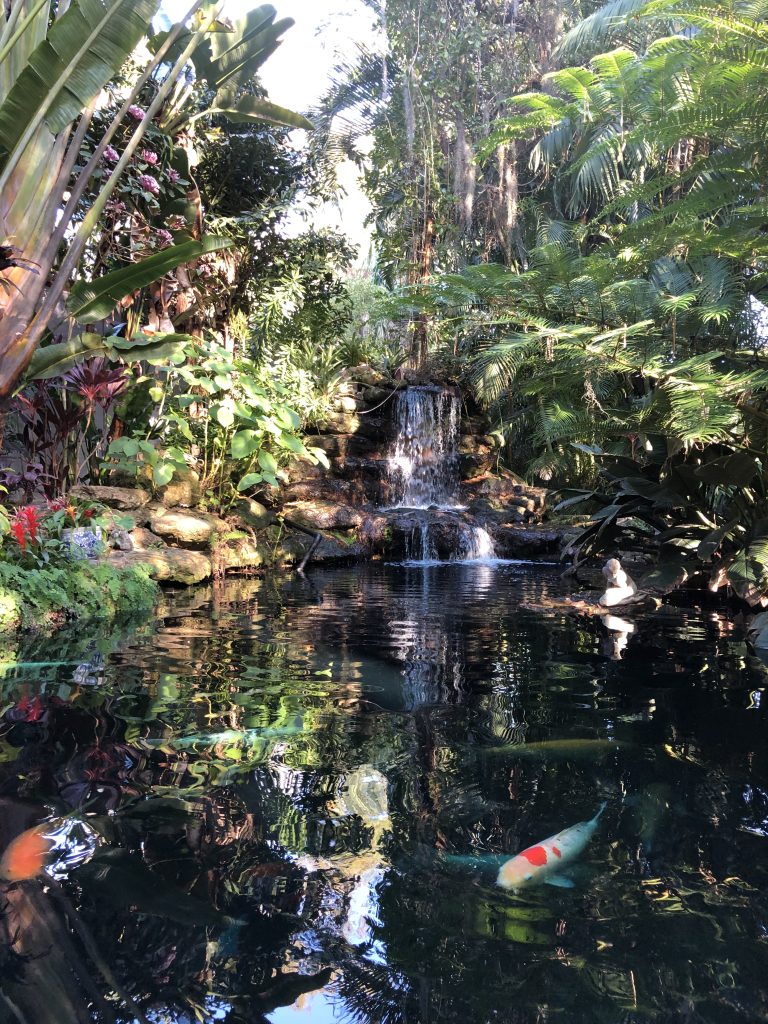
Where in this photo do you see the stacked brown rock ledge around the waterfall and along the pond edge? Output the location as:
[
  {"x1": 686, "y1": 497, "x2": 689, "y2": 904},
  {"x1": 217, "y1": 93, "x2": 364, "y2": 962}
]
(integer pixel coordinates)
[{"x1": 81, "y1": 367, "x2": 572, "y2": 584}]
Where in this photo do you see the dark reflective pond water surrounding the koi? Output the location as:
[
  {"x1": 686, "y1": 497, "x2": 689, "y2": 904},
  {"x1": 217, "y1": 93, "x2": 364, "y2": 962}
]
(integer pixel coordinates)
[{"x1": 0, "y1": 564, "x2": 768, "y2": 1024}]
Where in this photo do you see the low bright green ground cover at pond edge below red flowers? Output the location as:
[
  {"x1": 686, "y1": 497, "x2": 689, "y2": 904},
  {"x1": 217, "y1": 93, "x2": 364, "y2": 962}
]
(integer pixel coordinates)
[{"x1": 0, "y1": 561, "x2": 158, "y2": 633}]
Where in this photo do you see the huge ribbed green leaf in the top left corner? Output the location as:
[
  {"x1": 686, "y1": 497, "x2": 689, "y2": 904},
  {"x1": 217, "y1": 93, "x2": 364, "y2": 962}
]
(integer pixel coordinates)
[{"x1": 0, "y1": 0, "x2": 160, "y2": 163}]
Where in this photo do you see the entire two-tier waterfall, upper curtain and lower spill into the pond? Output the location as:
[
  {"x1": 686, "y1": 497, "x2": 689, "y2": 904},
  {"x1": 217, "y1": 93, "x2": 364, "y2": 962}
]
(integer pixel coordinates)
[{"x1": 388, "y1": 387, "x2": 496, "y2": 563}]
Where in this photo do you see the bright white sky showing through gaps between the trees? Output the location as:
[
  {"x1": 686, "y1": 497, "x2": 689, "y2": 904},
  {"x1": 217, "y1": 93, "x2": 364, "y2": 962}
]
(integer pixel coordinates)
[{"x1": 163, "y1": 0, "x2": 375, "y2": 265}]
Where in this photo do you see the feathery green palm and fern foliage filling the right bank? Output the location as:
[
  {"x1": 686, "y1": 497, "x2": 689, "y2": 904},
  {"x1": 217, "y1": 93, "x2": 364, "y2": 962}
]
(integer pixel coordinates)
[{"x1": 402, "y1": 2, "x2": 768, "y2": 603}]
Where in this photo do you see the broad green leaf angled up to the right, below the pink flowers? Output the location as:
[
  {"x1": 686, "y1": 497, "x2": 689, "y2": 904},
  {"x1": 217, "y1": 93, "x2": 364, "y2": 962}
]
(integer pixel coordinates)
[{"x1": 67, "y1": 234, "x2": 231, "y2": 324}]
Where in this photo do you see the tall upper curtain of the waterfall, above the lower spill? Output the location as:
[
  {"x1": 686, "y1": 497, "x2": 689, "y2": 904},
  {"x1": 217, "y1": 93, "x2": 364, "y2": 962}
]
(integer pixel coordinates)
[{"x1": 389, "y1": 387, "x2": 459, "y2": 509}]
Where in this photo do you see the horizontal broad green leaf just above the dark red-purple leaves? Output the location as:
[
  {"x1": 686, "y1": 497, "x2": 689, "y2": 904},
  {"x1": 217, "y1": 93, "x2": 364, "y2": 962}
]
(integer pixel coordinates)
[{"x1": 25, "y1": 334, "x2": 195, "y2": 383}]
